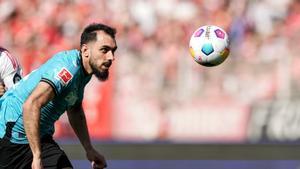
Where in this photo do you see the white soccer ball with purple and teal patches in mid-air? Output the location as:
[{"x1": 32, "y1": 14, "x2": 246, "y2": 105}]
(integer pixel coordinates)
[{"x1": 190, "y1": 25, "x2": 229, "y2": 67}]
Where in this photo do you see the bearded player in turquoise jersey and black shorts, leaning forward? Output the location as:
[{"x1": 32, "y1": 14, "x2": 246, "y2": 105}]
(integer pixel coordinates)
[{"x1": 0, "y1": 23, "x2": 117, "y2": 169}]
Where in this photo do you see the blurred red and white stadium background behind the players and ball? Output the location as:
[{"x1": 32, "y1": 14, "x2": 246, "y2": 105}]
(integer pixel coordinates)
[{"x1": 0, "y1": 0, "x2": 300, "y2": 169}]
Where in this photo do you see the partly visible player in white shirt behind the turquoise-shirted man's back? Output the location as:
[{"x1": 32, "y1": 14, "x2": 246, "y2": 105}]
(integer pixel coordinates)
[{"x1": 0, "y1": 46, "x2": 22, "y2": 97}]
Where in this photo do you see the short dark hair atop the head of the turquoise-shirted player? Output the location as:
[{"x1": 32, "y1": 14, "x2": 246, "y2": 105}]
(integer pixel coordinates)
[{"x1": 80, "y1": 23, "x2": 117, "y2": 47}]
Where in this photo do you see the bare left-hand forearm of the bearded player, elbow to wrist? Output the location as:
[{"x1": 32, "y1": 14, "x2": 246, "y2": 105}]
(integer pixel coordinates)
[{"x1": 23, "y1": 102, "x2": 41, "y2": 158}]
